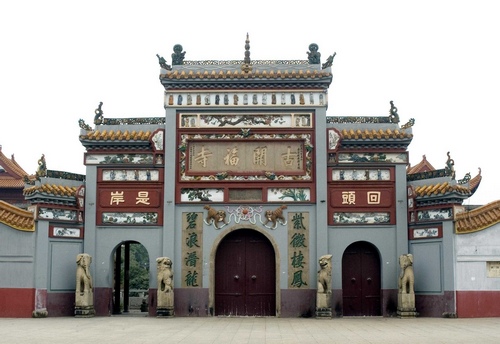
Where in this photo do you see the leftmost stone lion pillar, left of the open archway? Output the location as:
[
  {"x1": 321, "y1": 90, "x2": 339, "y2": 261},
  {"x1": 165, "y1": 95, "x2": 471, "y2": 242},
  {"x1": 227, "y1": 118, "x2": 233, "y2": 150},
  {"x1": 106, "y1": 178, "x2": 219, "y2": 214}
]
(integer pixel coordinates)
[{"x1": 75, "y1": 253, "x2": 95, "y2": 317}]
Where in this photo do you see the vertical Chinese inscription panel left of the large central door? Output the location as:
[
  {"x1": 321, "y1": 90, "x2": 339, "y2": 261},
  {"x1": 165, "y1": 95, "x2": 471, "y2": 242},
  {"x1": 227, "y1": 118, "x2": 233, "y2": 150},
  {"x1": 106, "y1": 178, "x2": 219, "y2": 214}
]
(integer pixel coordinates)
[{"x1": 181, "y1": 212, "x2": 203, "y2": 288}]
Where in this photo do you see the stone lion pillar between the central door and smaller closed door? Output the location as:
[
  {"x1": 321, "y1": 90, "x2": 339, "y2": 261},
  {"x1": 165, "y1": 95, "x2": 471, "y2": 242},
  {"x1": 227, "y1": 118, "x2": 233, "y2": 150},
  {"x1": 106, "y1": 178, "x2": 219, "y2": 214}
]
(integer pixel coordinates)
[{"x1": 316, "y1": 254, "x2": 332, "y2": 319}]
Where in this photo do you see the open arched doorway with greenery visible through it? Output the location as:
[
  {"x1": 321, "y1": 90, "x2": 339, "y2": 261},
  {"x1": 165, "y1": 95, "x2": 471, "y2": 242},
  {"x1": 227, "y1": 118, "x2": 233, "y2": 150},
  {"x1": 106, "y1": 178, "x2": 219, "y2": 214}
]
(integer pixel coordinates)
[{"x1": 113, "y1": 241, "x2": 149, "y2": 314}]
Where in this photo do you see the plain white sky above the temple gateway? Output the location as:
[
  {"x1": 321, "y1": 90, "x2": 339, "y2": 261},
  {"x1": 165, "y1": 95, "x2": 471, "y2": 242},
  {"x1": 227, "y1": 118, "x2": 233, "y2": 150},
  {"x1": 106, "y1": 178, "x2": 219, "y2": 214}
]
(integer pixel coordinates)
[{"x1": 0, "y1": 0, "x2": 500, "y2": 204}]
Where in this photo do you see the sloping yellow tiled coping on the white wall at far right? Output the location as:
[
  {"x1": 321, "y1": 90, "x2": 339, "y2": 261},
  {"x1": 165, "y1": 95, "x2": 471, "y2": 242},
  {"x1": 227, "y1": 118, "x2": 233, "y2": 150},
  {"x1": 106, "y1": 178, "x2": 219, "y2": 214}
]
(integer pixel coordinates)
[{"x1": 455, "y1": 200, "x2": 500, "y2": 234}]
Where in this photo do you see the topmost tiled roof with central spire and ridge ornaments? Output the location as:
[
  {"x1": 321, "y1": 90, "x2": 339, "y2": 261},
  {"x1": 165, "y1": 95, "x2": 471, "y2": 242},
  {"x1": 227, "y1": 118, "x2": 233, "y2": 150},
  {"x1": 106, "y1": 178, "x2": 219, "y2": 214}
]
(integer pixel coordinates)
[{"x1": 158, "y1": 35, "x2": 335, "y2": 90}]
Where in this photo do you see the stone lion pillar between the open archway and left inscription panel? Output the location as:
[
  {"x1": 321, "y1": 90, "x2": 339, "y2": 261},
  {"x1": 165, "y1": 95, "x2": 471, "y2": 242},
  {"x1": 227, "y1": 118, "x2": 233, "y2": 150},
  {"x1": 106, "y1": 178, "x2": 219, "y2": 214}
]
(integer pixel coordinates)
[{"x1": 156, "y1": 257, "x2": 174, "y2": 317}]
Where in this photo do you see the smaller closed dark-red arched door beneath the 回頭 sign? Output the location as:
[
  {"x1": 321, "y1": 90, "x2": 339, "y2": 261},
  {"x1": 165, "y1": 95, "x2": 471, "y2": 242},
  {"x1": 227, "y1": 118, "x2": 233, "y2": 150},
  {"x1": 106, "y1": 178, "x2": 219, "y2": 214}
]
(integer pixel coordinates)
[{"x1": 342, "y1": 241, "x2": 381, "y2": 316}]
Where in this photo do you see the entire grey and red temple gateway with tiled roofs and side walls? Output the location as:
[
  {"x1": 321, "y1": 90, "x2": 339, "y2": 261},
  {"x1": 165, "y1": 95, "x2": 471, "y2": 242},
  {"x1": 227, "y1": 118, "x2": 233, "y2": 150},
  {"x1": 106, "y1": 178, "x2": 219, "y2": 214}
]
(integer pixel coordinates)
[{"x1": 0, "y1": 36, "x2": 500, "y2": 318}]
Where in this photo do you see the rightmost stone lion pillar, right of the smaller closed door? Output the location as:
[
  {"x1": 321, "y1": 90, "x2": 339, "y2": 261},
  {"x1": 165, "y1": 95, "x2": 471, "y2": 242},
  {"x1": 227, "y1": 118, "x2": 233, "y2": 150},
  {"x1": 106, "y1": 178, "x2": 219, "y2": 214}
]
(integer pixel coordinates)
[{"x1": 397, "y1": 254, "x2": 418, "y2": 318}]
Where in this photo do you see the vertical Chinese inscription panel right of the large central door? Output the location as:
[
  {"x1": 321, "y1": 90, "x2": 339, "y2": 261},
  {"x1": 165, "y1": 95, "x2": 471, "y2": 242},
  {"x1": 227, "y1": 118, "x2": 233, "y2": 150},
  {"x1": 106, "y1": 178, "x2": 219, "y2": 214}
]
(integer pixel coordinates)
[{"x1": 288, "y1": 212, "x2": 309, "y2": 289}]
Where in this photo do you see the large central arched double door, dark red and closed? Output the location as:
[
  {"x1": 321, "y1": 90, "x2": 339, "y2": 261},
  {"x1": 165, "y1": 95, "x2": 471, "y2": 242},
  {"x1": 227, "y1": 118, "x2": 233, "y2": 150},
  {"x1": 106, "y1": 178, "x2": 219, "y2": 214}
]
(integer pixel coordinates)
[{"x1": 215, "y1": 229, "x2": 276, "y2": 316}]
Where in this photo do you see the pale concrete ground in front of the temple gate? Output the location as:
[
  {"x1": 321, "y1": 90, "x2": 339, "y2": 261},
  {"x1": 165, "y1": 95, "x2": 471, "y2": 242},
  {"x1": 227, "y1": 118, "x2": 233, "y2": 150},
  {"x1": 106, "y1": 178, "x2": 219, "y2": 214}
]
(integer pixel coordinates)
[{"x1": 0, "y1": 313, "x2": 500, "y2": 344}]
